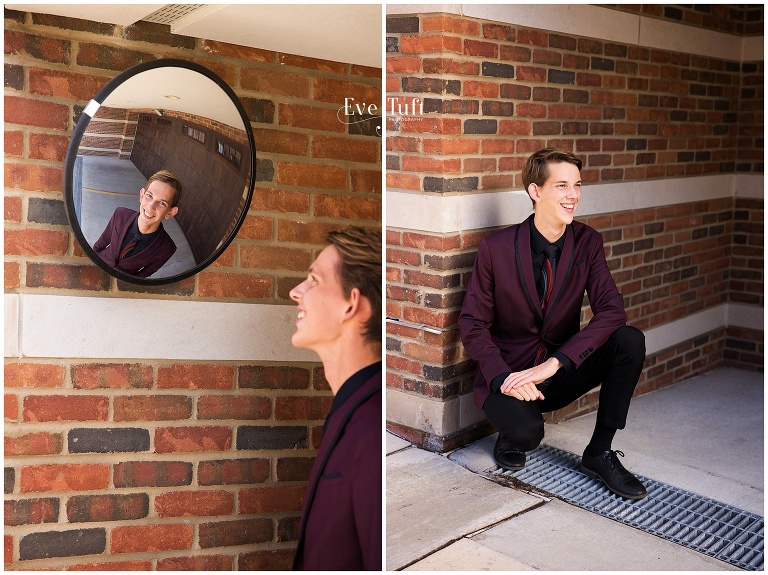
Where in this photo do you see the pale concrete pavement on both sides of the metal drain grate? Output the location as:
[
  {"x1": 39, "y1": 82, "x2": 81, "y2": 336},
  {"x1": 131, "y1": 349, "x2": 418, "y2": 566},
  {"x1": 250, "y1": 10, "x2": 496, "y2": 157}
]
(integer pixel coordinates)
[{"x1": 386, "y1": 368, "x2": 764, "y2": 571}]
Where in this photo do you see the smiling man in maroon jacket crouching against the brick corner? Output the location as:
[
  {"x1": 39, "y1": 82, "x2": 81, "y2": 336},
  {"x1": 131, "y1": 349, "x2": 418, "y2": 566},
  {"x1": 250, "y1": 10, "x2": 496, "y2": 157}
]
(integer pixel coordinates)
[{"x1": 458, "y1": 148, "x2": 646, "y2": 499}]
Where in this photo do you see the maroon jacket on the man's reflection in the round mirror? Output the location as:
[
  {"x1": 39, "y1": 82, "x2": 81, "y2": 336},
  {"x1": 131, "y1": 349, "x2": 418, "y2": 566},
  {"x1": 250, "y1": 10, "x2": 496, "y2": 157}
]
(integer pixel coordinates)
[{"x1": 93, "y1": 208, "x2": 176, "y2": 278}]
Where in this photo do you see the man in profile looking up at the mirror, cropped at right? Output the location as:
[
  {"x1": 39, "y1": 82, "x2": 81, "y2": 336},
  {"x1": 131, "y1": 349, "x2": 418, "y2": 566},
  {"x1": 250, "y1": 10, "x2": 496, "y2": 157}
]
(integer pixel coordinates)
[{"x1": 290, "y1": 227, "x2": 382, "y2": 571}]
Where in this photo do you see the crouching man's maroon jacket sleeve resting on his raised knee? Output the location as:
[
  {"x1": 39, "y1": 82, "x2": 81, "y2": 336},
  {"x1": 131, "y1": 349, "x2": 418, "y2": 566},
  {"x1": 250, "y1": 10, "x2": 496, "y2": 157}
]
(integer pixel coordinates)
[{"x1": 558, "y1": 232, "x2": 627, "y2": 369}]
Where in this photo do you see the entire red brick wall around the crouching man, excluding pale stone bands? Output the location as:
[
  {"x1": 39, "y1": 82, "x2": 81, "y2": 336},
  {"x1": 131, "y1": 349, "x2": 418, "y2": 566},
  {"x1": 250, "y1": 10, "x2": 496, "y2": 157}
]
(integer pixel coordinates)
[{"x1": 386, "y1": 7, "x2": 764, "y2": 451}]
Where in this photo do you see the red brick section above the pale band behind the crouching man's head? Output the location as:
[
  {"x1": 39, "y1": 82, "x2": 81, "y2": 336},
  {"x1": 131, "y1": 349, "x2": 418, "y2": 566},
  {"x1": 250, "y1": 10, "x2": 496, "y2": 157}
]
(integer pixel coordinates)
[{"x1": 386, "y1": 14, "x2": 763, "y2": 192}]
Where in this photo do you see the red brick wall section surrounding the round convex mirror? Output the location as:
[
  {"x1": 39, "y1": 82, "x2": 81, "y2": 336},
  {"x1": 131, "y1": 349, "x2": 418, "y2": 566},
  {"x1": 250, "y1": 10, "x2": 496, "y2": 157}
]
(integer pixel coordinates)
[{"x1": 5, "y1": 11, "x2": 381, "y2": 302}]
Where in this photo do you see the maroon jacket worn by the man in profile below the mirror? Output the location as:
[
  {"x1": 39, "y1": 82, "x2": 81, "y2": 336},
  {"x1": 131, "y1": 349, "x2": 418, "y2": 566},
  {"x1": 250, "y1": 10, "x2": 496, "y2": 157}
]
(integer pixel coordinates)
[{"x1": 293, "y1": 371, "x2": 382, "y2": 571}]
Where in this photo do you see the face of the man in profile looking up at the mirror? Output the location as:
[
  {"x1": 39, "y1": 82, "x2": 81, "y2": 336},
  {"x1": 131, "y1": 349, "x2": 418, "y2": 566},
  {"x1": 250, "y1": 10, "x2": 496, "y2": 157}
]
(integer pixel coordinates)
[{"x1": 290, "y1": 245, "x2": 349, "y2": 352}]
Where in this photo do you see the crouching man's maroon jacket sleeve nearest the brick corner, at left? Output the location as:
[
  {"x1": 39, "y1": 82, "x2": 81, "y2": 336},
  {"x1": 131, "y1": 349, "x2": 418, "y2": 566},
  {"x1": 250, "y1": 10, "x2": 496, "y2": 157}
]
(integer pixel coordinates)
[{"x1": 458, "y1": 238, "x2": 509, "y2": 389}]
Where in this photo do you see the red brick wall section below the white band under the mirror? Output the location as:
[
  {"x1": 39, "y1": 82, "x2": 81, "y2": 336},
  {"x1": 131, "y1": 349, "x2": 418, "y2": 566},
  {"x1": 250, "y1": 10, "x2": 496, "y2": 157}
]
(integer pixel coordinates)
[{"x1": 5, "y1": 361, "x2": 331, "y2": 569}]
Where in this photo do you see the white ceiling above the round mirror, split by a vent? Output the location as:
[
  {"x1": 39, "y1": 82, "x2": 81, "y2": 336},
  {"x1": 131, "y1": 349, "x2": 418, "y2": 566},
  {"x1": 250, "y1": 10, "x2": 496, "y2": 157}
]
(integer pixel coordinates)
[{"x1": 5, "y1": 3, "x2": 382, "y2": 68}]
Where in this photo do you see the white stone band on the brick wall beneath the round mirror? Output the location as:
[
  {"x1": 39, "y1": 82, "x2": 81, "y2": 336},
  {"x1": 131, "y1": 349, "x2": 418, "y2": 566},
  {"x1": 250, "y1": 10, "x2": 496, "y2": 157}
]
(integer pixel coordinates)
[{"x1": 5, "y1": 294, "x2": 319, "y2": 362}]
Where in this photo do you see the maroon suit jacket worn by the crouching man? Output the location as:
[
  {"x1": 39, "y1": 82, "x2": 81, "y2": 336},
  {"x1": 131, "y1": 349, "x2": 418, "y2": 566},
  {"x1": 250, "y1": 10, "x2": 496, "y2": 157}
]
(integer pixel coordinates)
[{"x1": 458, "y1": 216, "x2": 627, "y2": 407}]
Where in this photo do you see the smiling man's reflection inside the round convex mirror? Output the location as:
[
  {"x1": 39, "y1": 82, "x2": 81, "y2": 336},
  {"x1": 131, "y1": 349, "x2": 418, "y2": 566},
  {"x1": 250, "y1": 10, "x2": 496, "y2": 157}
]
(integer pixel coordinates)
[{"x1": 93, "y1": 170, "x2": 182, "y2": 278}]
